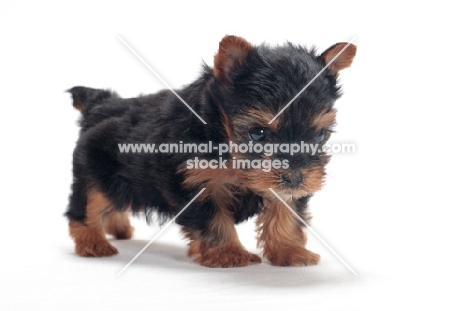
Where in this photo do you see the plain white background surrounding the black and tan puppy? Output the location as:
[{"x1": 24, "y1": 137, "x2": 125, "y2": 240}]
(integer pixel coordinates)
[{"x1": 0, "y1": 1, "x2": 468, "y2": 310}]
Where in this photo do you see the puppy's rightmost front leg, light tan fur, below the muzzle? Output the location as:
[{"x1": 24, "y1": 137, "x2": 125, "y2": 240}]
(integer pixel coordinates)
[{"x1": 257, "y1": 197, "x2": 320, "y2": 266}]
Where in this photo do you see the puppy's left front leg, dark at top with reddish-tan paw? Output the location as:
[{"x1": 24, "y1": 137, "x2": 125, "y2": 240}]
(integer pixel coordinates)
[{"x1": 183, "y1": 208, "x2": 262, "y2": 268}]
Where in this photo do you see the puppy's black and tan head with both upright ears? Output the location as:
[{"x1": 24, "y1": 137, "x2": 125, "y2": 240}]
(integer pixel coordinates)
[{"x1": 213, "y1": 36, "x2": 356, "y2": 198}]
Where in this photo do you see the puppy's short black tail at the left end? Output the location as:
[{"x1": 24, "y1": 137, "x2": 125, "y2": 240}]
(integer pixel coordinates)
[{"x1": 67, "y1": 86, "x2": 118, "y2": 113}]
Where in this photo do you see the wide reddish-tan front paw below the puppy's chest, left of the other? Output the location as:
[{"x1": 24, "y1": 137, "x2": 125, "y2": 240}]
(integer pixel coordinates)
[{"x1": 192, "y1": 247, "x2": 262, "y2": 268}]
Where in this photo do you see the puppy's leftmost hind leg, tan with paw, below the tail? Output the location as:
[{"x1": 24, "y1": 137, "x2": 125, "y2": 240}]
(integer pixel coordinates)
[{"x1": 69, "y1": 190, "x2": 118, "y2": 257}]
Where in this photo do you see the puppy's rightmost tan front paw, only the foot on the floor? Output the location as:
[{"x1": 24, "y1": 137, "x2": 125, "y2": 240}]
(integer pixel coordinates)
[{"x1": 265, "y1": 248, "x2": 320, "y2": 267}]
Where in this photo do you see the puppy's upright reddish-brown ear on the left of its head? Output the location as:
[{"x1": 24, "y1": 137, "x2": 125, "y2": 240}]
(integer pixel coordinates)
[{"x1": 213, "y1": 36, "x2": 253, "y2": 80}]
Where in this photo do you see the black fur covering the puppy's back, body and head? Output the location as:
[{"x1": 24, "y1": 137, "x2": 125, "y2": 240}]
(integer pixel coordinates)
[{"x1": 66, "y1": 36, "x2": 352, "y2": 246}]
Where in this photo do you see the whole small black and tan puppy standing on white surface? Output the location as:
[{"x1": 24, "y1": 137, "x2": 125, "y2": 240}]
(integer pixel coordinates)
[{"x1": 66, "y1": 36, "x2": 356, "y2": 267}]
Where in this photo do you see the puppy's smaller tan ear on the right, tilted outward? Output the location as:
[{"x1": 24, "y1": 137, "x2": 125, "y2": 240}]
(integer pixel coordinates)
[{"x1": 320, "y1": 42, "x2": 357, "y2": 76}]
